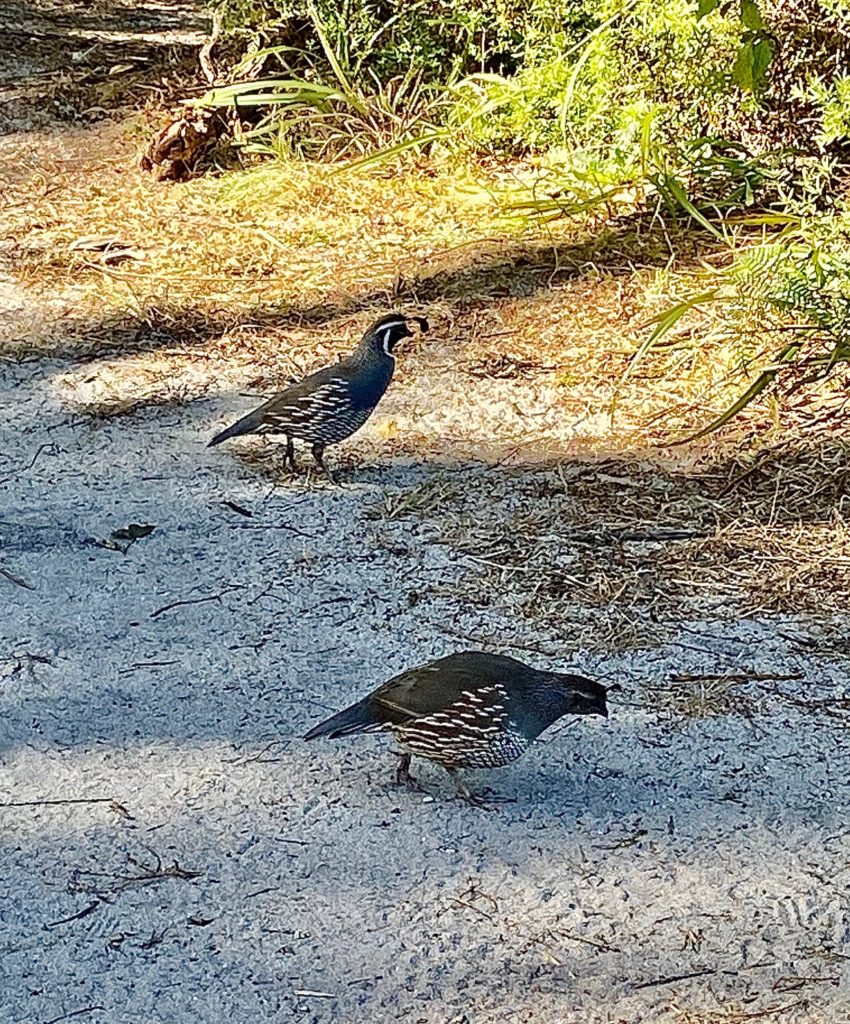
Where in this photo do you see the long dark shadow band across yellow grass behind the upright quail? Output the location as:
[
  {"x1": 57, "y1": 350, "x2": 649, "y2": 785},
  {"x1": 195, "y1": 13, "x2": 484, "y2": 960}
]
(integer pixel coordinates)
[{"x1": 6, "y1": 216, "x2": 717, "y2": 362}]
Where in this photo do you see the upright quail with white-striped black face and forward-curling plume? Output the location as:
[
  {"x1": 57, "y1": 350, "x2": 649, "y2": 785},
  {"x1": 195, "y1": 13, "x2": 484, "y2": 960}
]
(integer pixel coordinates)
[{"x1": 208, "y1": 313, "x2": 428, "y2": 477}]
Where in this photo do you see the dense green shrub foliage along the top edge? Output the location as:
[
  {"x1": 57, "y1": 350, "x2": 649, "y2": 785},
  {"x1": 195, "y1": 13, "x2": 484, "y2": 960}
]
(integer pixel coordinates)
[{"x1": 206, "y1": 0, "x2": 850, "y2": 174}]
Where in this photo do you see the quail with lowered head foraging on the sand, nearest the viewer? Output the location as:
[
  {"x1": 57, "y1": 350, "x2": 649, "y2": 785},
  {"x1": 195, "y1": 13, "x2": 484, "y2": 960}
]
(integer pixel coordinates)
[{"x1": 304, "y1": 650, "x2": 608, "y2": 799}]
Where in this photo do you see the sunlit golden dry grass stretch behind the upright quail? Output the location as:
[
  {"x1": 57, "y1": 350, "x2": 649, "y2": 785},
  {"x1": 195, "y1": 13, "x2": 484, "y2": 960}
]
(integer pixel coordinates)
[{"x1": 0, "y1": 117, "x2": 790, "y2": 449}]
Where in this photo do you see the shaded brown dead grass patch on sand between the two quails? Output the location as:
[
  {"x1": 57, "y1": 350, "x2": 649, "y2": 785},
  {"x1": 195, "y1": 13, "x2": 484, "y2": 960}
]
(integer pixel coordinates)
[{"x1": 378, "y1": 441, "x2": 850, "y2": 647}]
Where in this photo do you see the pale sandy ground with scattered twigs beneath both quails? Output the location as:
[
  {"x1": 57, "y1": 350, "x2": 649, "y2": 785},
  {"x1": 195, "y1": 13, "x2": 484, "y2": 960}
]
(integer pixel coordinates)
[{"x1": 0, "y1": 8, "x2": 850, "y2": 1024}]
